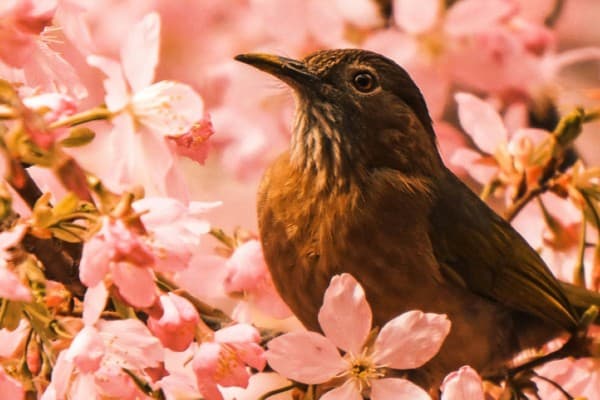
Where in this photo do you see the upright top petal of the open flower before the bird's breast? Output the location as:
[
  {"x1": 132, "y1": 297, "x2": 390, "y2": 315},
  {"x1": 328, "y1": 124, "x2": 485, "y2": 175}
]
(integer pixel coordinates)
[{"x1": 319, "y1": 273, "x2": 372, "y2": 354}]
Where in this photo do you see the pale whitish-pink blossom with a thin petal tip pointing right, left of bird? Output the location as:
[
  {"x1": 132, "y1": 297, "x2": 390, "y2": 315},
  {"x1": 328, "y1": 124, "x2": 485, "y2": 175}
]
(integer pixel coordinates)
[{"x1": 132, "y1": 197, "x2": 220, "y2": 272}]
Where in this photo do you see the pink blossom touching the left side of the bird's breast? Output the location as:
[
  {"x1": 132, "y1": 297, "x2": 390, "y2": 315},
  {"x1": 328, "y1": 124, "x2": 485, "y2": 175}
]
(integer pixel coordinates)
[{"x1": 224, "y1": 240, "x2": 292, "y2": 320}]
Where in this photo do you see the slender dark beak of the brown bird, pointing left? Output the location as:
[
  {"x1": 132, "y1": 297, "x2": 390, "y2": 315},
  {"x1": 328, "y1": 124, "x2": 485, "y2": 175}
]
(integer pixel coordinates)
[{"x1": 235, "y1": 53, "x2": 320, "y2": 89}]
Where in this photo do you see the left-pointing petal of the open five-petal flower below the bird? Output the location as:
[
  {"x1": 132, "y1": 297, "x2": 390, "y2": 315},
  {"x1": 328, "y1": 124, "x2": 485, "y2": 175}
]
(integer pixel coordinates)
[{"x1": 267, "y1": 332, "x2": 348, "y2": 385}]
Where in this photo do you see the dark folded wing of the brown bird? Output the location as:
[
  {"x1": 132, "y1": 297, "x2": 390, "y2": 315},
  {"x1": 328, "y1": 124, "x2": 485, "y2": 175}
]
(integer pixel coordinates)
[{"x1": 429, "y1": 172, "x2": 578, "y2": 330}]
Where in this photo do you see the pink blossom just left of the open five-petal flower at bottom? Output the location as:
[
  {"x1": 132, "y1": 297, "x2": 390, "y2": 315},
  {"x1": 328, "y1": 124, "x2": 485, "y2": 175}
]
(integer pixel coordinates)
[{"x1": 192, "y1": 324, "x2": 266, "y2": 400}]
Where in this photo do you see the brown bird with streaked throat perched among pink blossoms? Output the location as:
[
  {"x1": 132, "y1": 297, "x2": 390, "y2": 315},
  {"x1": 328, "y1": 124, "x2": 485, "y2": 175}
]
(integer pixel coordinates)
[{"x1": 236, "y1": 49, "x2": 592, "y2": 391}]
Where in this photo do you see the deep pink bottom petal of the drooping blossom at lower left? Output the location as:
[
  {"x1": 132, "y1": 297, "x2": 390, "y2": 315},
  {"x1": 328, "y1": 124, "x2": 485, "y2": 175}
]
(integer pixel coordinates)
[{"x1": 112, "y1": 262, "x2": 156, "y2": 307}]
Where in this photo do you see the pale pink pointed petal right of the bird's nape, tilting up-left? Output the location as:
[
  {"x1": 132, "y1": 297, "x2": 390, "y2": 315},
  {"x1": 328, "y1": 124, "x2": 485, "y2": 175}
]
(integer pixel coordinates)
[{"x1": 454, "y1": 93, "x2": 508, "y2": 154}]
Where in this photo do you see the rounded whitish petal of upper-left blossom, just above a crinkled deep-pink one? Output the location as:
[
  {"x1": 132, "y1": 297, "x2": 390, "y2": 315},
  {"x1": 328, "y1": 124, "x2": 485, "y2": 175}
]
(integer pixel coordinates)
[{"x1": 132, "y1": 81, "x2": 204, "y2": 136}]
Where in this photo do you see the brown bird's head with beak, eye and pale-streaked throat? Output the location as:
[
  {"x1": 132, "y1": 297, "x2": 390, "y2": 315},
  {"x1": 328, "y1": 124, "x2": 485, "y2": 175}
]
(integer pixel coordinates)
[{"x1": 235, "y1": 49, "x2": 442, "y2": 186}]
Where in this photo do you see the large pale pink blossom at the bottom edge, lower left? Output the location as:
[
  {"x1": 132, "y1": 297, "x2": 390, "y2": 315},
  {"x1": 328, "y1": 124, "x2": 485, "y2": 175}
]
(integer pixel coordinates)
[{"x1": 42, "y1": 319, "x2": 163, "y2": 400}]
